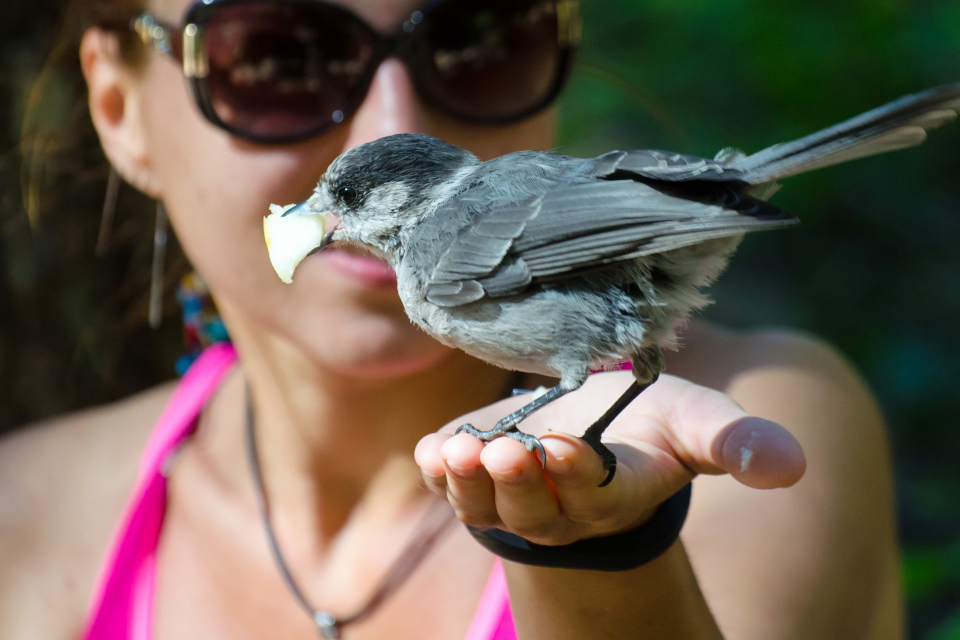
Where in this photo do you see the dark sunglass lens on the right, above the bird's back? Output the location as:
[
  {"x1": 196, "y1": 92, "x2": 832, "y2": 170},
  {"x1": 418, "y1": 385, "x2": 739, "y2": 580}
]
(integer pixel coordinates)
[{"x1": 413, "y1": 0, "x2": 566, "y2": 121}]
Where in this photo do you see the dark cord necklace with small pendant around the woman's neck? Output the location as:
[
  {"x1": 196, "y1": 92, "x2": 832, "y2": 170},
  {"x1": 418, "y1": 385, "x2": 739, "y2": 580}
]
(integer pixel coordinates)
[{"x1": 245, "y1": 386, "x2": 454, "y2": 640}]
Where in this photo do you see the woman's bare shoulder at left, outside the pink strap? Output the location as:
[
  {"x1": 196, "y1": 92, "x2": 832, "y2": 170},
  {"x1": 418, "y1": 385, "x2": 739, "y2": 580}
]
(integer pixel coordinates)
[{"x1": 0, "y1": 384, "x2": 174, "y2": 638}]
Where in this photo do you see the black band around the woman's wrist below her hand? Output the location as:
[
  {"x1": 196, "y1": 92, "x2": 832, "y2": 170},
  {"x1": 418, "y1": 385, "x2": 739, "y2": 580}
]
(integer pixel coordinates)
[{"x1": 467, "y1": 484, "x2": 691, "y2": 571}]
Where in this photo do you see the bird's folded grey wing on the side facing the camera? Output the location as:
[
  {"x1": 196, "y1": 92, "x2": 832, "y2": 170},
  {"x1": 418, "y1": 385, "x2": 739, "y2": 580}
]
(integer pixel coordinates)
[{"x1": 427, "y1": 175, "x2": 795, "y2": 307}]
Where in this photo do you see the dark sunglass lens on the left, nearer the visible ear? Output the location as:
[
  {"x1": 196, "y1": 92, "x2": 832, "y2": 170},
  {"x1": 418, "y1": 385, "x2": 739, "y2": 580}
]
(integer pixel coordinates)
[{"x1": 206, "y1": 2, "x2": 374, "y2": 139}]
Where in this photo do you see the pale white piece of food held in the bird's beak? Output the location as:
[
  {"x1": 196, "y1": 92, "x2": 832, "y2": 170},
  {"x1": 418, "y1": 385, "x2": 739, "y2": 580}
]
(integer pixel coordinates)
[{"x1": 263, "y1": 204, "x2": 326, "y2": 284}]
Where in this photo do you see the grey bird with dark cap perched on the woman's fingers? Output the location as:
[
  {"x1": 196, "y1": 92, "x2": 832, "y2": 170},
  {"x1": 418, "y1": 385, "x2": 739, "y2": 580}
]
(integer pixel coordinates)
[{"x1": 268, "y1": 83, "x2": 960, "y2": 486}]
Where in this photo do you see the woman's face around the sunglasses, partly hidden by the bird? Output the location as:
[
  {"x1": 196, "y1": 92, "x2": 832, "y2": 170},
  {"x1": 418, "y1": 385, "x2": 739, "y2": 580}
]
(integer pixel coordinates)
[{"x1": 139, "y1": 0, "x2": 554, "y2": 376}]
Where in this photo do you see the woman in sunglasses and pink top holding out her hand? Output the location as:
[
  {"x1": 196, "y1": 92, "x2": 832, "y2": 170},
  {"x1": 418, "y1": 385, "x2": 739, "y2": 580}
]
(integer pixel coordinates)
[{"x1": 0, "y1": 0, "x2": 901, "y2": 639}]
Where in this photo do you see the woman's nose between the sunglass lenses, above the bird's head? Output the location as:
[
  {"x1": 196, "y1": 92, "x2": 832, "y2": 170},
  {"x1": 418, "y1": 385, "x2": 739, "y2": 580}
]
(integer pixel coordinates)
[{"x1": 344, "y1": 58, "x2": 422, "y2": 149}]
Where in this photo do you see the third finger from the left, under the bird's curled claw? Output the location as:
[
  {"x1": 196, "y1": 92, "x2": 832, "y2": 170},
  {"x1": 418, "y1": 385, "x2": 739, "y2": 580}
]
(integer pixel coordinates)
[{"x1": 480, "y1": 438, "x2": 575, "y2": 544}]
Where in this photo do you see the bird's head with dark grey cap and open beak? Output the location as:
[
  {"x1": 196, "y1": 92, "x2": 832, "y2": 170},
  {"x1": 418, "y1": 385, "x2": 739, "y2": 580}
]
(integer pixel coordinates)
[{"x1": 284, "y1": 134, "x2": 479, "y2": 268}]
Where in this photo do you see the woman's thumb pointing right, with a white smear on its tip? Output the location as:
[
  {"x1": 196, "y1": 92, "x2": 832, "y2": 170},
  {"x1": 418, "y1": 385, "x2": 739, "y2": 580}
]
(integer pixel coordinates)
[{"x1": 641, "y1": 376, "x2": 806, "y2": 488}]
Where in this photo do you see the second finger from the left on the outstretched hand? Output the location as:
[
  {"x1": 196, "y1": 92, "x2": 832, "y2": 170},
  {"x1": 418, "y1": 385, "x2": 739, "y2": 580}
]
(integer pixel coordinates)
[{"x1": 440, "y1": 433, "x2": 502, "y2": 527}]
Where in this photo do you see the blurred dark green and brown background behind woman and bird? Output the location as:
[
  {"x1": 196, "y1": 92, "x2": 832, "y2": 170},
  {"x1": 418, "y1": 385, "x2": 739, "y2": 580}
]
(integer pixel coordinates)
[{"x1": 0, "y1": 0, "x2": 960, "y2": 640}]
